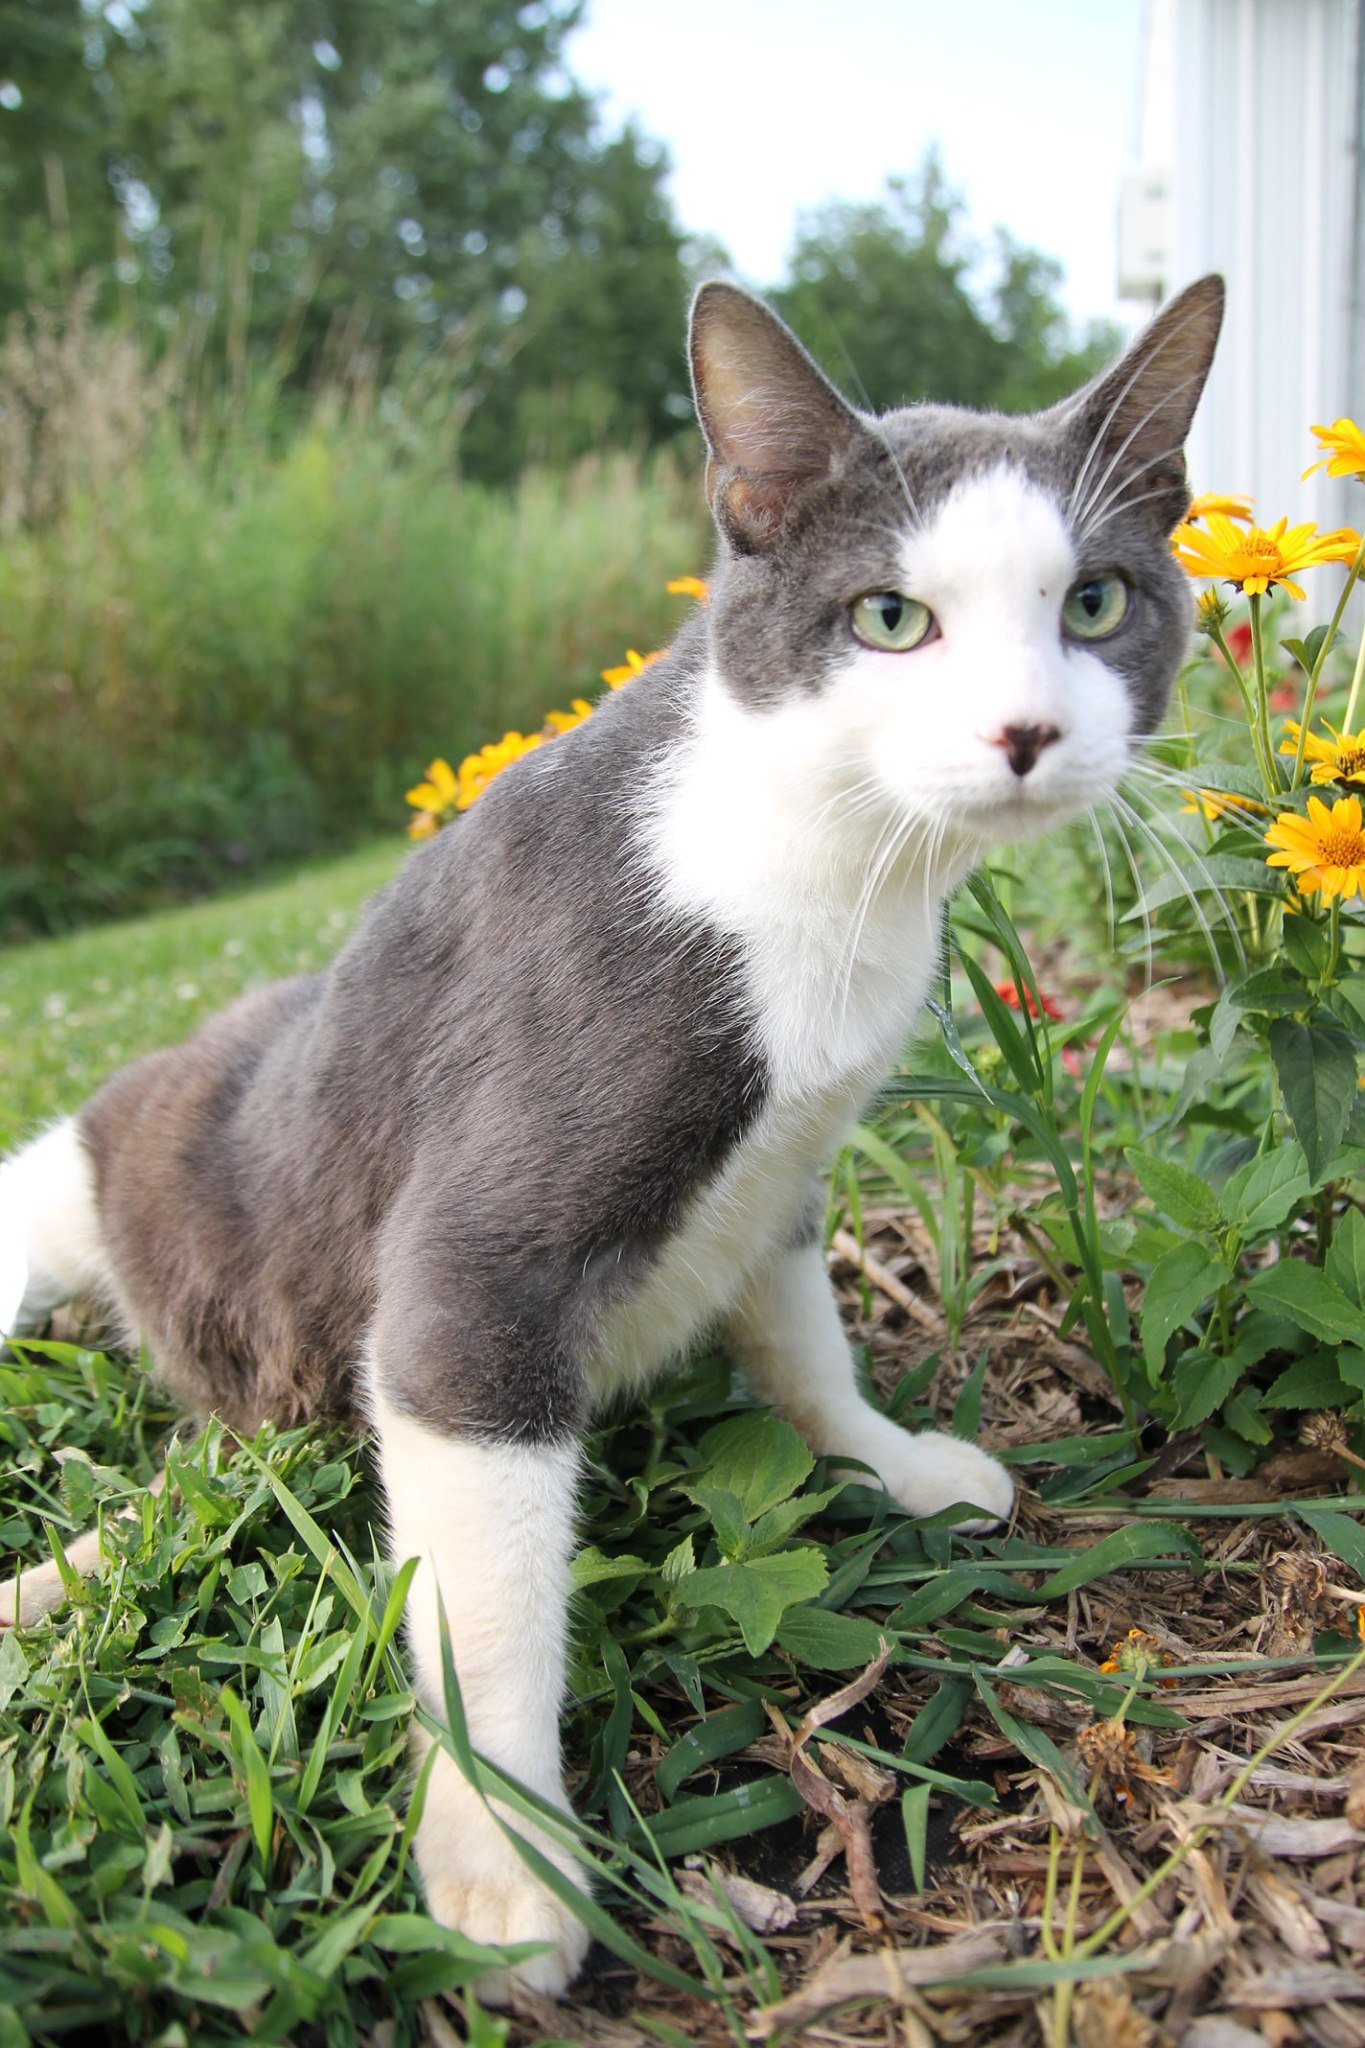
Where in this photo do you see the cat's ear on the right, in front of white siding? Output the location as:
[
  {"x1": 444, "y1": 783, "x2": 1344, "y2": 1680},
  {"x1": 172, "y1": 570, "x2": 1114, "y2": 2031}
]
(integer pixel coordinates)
[{"x1": 1054, "y1": 276, "x2": 1224, "y2": 532}]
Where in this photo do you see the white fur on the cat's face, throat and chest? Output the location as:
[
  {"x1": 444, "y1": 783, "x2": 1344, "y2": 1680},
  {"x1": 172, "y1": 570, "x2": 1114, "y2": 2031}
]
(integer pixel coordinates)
[{"x1": 645, "y1": 467, "x2": 1132, "y2": 1104}]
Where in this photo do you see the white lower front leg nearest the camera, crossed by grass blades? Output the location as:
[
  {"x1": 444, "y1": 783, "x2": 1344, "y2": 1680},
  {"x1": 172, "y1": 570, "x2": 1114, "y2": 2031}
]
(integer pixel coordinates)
[{"x1": 370, "y1": 1350, "x2": 589, "y2": 2003}]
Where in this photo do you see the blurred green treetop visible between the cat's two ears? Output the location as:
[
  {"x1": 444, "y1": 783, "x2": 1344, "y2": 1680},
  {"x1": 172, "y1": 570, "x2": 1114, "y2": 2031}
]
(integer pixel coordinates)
[{"x1": 772, "y1": 152, "x2": 1115, "y2": 423}]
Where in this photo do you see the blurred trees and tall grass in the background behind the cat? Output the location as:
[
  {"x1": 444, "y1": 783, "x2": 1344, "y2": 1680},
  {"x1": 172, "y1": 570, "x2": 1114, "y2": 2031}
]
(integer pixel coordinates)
[{"x1": 0, "y1": 0, "x2": 1113, "y2": 936}]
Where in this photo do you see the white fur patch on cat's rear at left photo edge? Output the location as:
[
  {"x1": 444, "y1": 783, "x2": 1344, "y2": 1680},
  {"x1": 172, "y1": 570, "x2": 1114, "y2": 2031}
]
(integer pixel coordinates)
[{"x1": 0, "y1": 1118, "x2": 111, "y2": 1335}]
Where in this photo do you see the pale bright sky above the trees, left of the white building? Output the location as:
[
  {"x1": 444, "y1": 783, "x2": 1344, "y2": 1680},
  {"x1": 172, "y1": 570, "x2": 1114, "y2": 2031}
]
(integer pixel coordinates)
[{"x1": 565, "y1": 0, "x2": 1142, "y2": 324}]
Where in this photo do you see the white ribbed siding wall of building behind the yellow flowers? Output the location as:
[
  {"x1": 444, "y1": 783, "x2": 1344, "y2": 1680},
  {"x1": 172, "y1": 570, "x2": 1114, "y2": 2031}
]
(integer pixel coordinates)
[{"x1": 1140, "y1": 0, "x2": 1365, "y2": 526}]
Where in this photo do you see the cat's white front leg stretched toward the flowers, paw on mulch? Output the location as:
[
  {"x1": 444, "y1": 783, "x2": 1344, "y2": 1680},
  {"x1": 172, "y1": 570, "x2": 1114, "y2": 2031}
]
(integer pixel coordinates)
[{"x1": 726, "y1": 1243, "x2": 1015, "y2": 1530}]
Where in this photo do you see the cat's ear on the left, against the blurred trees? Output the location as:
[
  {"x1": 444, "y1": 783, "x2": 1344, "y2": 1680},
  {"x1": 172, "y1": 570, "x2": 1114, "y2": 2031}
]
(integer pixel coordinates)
[{"x1": 688, "y1": 283, "x2": 862, "y2": 553}]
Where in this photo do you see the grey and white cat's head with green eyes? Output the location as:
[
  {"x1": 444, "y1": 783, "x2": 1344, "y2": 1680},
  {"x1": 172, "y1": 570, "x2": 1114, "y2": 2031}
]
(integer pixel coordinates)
[{"x1": 692, "y1": 276, "x2": 1224, "y2": 844}]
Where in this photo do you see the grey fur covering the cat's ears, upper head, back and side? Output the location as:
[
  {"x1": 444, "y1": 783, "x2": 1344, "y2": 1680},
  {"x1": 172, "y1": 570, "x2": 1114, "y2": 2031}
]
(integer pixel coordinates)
[{"x1": 80, "y1": 281, "x2": 1222, "y2": 1440}]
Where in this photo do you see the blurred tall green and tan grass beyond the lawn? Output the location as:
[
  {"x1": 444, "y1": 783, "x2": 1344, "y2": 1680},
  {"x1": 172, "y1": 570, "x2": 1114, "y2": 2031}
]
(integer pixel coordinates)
[{"x1": 0, "y1": 303, "x2": 704, "y2": 932}]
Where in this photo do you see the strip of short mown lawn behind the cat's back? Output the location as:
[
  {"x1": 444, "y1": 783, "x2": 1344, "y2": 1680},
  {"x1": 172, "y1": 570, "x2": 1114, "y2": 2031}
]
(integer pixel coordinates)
[{"x1": 0, "y1": 838, "x2": 405, "y2": 1151}]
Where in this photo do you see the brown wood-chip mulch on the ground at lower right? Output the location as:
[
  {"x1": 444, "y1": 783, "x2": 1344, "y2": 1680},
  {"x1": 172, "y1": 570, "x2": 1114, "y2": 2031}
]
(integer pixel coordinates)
[{"x1": 497, "y1": 1208, "x2": 1365, "y2": 2048}]
